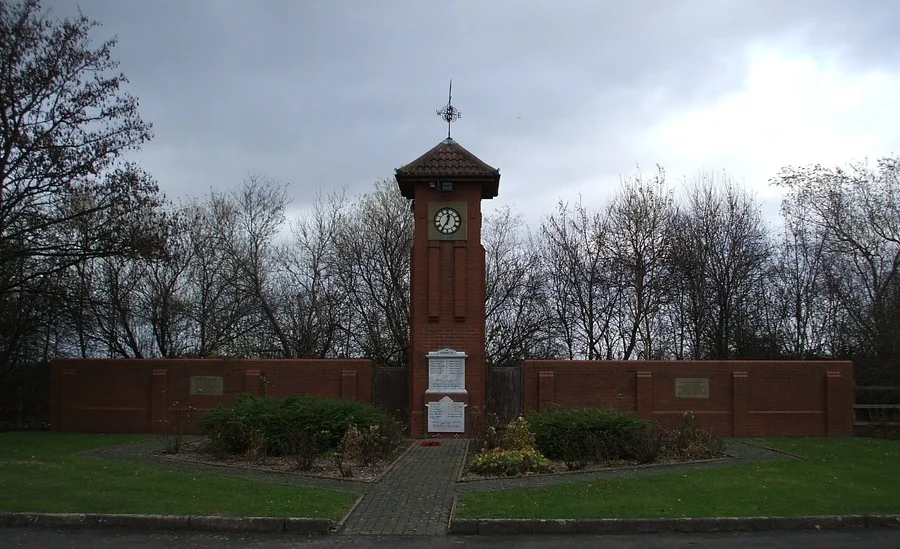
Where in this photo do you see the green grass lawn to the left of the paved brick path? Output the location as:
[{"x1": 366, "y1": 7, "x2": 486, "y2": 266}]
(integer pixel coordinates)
[{"x1": 0, "y1": 432, "x2": 356, "y2": 519}]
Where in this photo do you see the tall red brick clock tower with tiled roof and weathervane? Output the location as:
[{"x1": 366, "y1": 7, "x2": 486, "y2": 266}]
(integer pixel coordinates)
[{"x1": 396, "y1": 128, "x2": 500, "y2": 437}]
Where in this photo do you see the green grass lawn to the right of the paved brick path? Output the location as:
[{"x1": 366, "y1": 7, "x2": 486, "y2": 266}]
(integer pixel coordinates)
[{"x1": 456, "y1": 438, "x2": 900, "y2": 519}]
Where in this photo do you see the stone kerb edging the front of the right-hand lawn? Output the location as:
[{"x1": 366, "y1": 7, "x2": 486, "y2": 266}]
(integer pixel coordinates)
[{"x1": 447, "y1": 512, "x2": 900, "y2": 536}]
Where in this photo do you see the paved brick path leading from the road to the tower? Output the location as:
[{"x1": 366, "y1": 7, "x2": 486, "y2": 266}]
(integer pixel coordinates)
[{"x1": 341, "y1": 440, "x2": 466, "y2": 535}]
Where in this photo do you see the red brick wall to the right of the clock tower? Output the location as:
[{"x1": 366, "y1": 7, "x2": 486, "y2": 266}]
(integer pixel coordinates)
[{"x1": 523, "y1": 360, "x2": 854, "y2": 436}]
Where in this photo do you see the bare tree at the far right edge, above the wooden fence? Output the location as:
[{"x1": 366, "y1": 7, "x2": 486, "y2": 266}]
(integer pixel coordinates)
[{"x1": 774, "y1": 158, "x2": 900, "y2": 364}]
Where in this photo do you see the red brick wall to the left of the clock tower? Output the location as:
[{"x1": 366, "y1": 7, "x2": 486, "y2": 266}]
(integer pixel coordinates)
[{"x1": 50, "y1": 359, "x2": 372, "y2": 433}]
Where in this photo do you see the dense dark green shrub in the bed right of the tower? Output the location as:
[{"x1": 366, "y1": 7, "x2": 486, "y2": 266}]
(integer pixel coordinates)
[{"x1": 528, "y1": 408, "x2": 651, "y2": 462}]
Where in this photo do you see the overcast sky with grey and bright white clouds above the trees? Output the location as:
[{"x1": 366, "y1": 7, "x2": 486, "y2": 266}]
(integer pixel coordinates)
[{"x1": 45, "y1": 0, "x2": 900, "y2": 226}]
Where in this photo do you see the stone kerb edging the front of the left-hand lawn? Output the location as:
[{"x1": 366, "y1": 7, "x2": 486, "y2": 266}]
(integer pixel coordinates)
[{"x1": 0, "y1": 512, "x2": 334, "y2": 536}]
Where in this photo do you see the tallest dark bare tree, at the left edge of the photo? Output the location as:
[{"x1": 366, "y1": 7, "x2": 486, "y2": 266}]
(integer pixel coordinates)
[{"x1": 0, "y1": 0, "x2": 160, "y2": 375}]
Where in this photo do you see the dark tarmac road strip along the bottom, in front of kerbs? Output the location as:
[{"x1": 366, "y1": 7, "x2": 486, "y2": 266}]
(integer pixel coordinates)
[{"x1": 0, "y1": 528, "x2": 900, "y2": 549}]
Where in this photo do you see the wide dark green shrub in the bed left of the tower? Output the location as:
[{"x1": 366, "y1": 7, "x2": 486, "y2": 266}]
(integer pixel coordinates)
[{"x1": 200, "y1": 395, "x2": 400, "y2": 458}]
